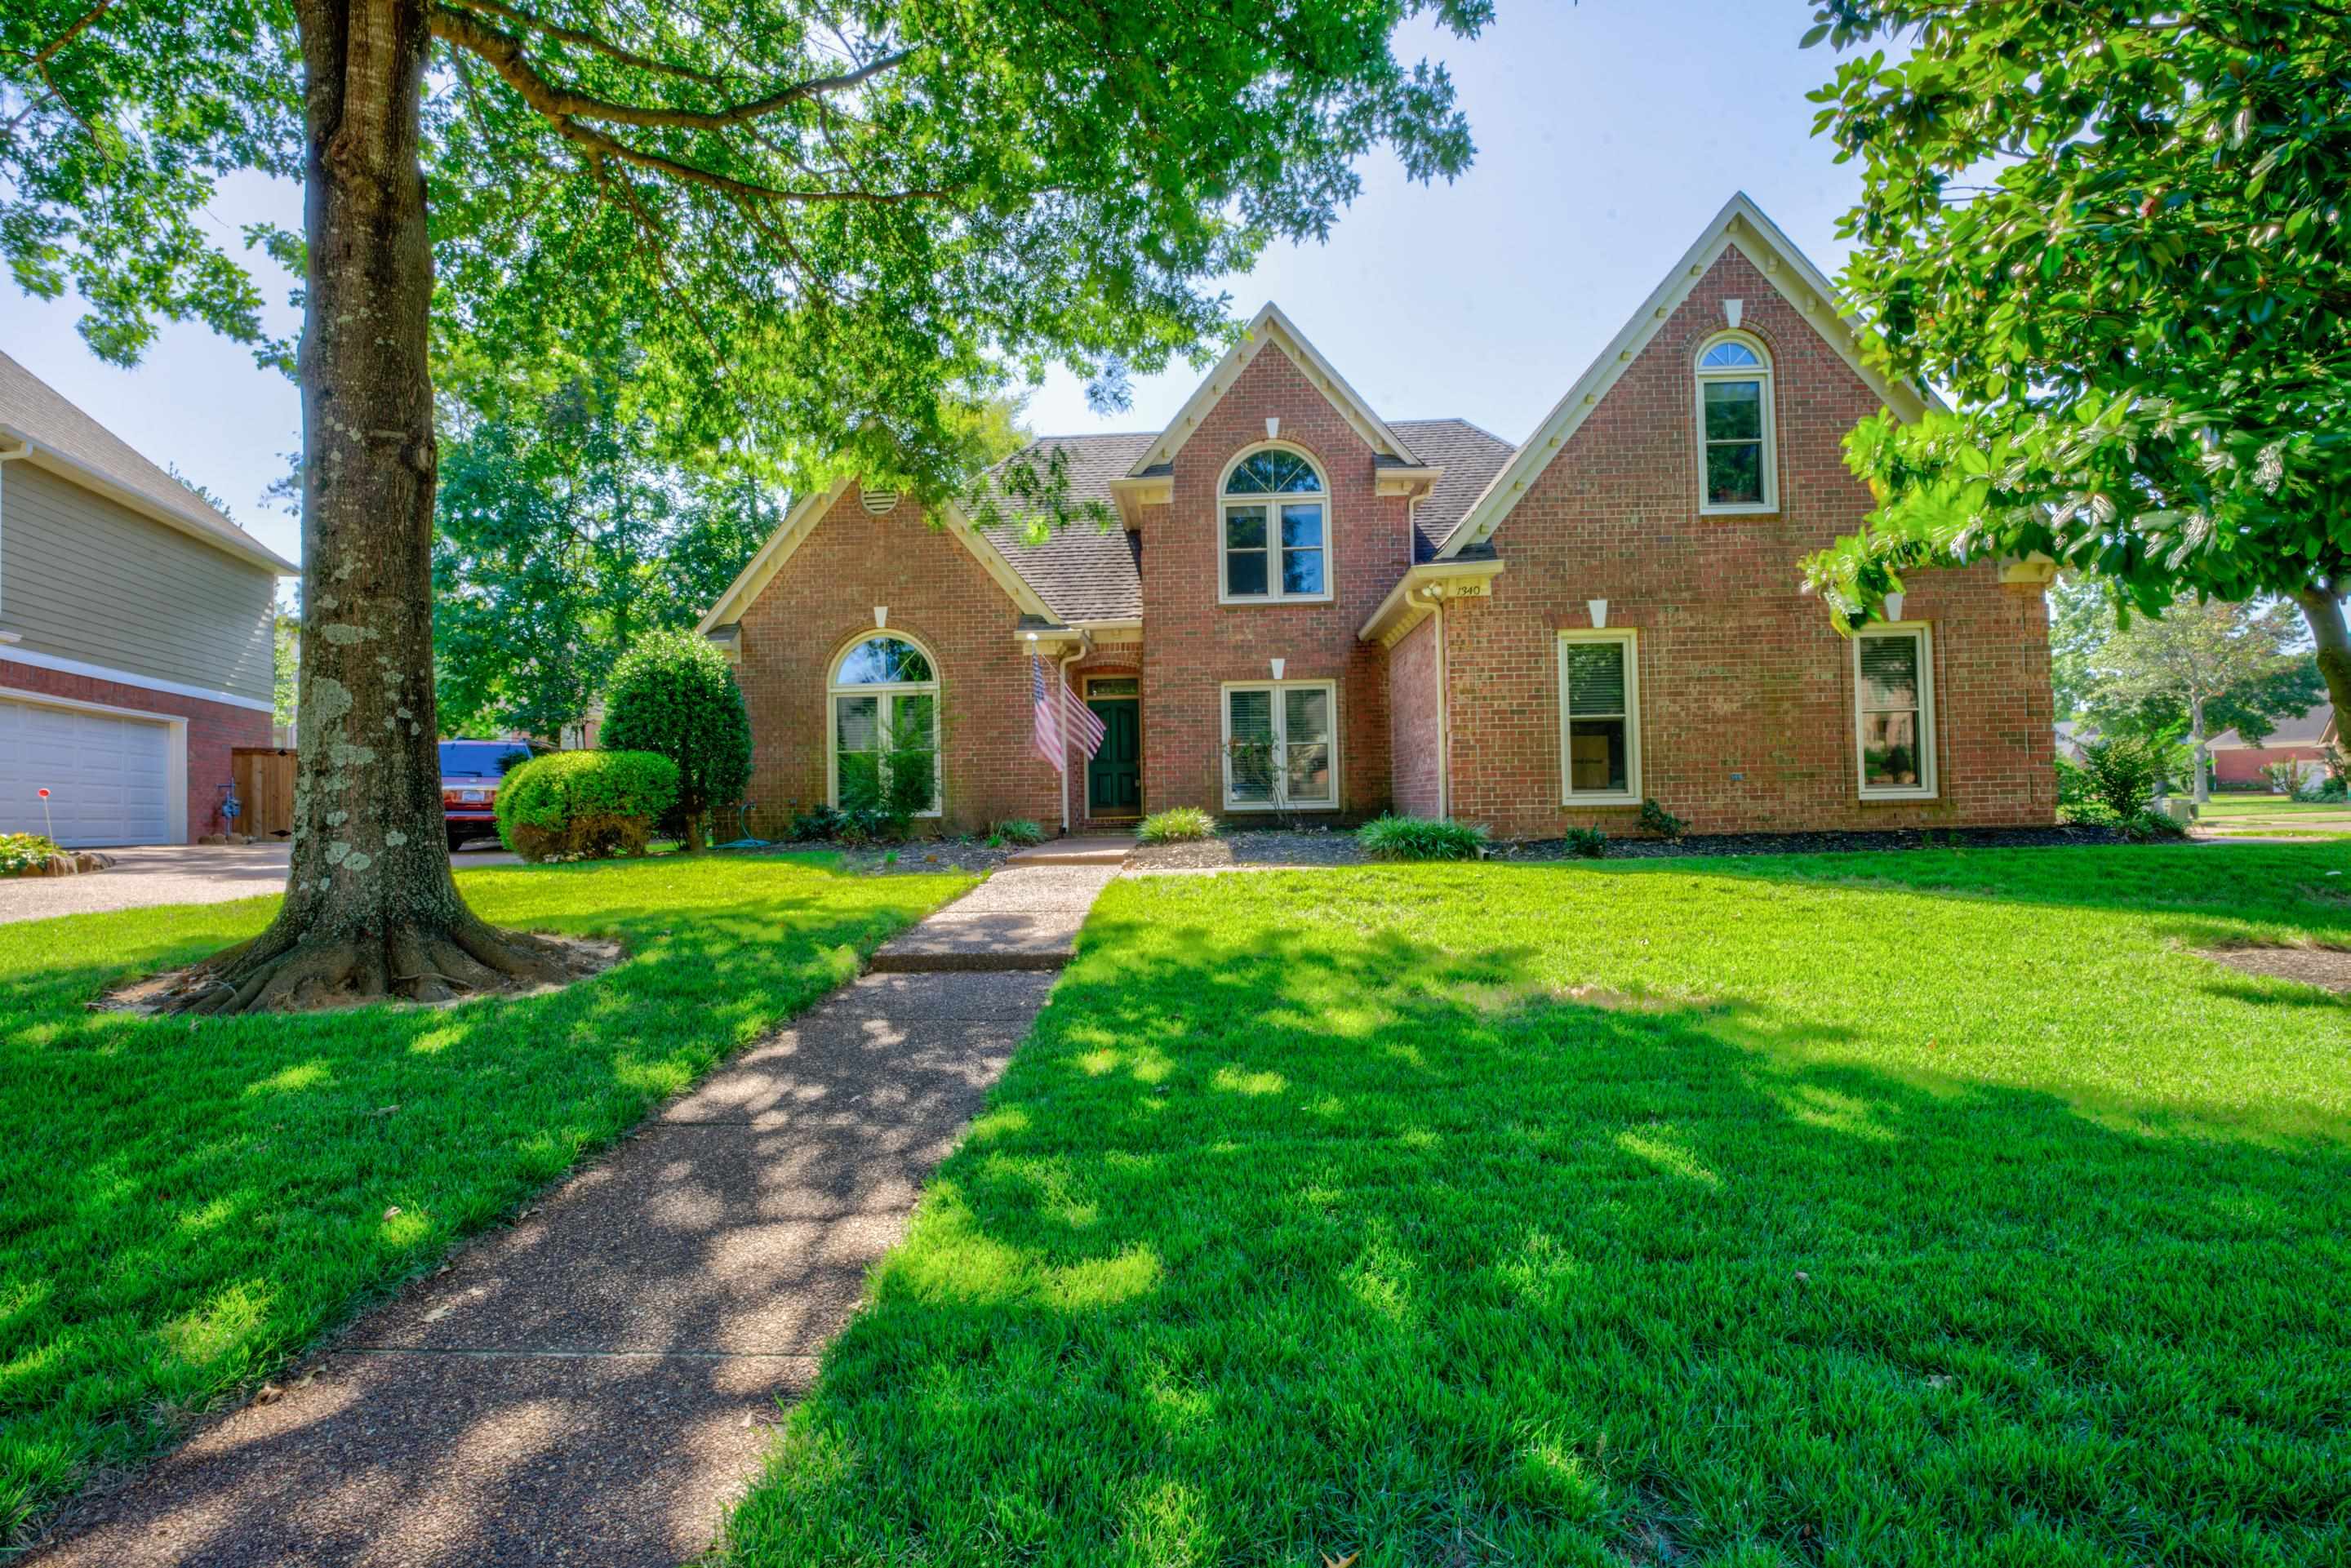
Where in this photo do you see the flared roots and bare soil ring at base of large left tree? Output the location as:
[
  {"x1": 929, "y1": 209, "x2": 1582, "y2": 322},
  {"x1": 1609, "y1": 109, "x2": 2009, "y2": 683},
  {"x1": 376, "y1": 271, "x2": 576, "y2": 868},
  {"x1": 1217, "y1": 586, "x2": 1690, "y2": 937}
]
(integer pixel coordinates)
[{"x1": 158, "y1": 917, "x2": 599, "y2": 1018}]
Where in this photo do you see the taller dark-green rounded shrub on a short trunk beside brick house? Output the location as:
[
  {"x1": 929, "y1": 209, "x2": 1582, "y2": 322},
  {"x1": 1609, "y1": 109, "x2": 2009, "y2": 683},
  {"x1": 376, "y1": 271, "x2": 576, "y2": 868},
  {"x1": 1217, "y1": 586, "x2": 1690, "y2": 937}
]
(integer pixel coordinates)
[{"x1": 599, "y1": 633, "x2": 750, "y2": 849}]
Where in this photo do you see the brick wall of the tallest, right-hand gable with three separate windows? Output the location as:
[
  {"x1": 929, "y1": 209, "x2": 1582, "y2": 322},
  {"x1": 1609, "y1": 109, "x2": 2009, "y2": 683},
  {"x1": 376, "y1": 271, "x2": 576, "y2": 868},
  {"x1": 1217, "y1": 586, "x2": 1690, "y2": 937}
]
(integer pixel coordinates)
[{"x1": 1446, "y1": 249, "x2": 2055, "y2": 837}]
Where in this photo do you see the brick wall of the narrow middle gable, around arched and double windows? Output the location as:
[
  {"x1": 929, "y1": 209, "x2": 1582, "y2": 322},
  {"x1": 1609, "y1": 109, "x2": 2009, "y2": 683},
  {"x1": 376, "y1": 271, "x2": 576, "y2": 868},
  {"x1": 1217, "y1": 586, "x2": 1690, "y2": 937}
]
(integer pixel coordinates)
[{"x1": 1143, "y1": 345, "x2": 1411, "y2": 820}]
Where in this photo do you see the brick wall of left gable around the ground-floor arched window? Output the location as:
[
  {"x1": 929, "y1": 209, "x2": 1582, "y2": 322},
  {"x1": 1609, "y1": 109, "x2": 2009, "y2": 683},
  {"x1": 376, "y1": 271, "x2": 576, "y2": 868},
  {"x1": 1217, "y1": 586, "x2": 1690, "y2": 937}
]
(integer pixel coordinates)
[{"x1": 736, "y1": 484, "x2": 1060, "y2": 837}]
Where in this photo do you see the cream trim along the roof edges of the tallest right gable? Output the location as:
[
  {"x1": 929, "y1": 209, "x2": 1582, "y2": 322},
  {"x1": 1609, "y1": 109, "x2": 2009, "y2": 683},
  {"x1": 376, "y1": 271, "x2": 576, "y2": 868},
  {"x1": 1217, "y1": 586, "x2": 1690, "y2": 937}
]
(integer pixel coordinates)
[{"x1": 1437, "y1": 190, "x2": 1940, "y2": 559}]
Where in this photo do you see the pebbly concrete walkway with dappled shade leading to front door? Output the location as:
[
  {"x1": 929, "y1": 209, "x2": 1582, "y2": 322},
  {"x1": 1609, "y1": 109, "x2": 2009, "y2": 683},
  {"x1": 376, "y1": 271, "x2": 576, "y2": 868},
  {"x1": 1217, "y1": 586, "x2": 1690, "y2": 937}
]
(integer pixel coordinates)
[{"x1": 29, "y1": 865, "x2": 1117, "y2": 1568}]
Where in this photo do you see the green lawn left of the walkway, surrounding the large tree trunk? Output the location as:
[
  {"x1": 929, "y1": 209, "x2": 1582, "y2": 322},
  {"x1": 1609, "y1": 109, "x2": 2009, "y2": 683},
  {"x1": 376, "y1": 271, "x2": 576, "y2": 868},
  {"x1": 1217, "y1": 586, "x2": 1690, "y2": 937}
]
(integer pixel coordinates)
[{"x1": 0, "y1": 858, "x2": 969, "y2": 1544}]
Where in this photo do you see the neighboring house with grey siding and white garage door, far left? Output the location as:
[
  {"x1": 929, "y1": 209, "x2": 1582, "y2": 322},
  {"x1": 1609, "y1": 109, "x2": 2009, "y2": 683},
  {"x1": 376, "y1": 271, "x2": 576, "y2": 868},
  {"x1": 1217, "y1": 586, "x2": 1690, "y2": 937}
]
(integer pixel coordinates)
[{"x1": 0, "y1": 355, "x2": 299, "y2": 844}]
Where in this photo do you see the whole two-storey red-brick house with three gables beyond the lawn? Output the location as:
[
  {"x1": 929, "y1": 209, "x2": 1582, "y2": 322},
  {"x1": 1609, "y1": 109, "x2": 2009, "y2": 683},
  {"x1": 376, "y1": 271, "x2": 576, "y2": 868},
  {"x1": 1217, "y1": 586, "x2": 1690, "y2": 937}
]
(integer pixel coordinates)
[{"x1": 703, "y1": 195, "x2": 2055, "y2": 837}]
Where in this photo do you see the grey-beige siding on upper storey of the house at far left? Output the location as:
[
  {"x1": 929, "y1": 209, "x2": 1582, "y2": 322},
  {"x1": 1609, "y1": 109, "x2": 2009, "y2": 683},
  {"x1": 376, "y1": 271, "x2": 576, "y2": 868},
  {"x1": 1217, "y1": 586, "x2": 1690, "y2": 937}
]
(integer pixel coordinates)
[{"x1": 0, "y1": 463, "x2": 278, "y2": 700}]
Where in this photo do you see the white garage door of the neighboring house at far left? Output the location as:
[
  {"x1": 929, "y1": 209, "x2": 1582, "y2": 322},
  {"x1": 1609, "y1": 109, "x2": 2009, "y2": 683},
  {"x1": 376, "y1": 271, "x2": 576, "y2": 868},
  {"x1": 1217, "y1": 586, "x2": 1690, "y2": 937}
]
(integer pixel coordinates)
[{"x1": 0, "y1": 698, "x2": 171, "y2": 846}]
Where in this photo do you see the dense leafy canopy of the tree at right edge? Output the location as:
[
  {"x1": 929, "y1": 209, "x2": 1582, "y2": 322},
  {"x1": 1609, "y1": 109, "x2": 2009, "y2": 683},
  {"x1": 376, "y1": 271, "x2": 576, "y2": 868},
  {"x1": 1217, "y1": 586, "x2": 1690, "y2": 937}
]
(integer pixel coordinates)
[{"x1": 1806, "y1": 0, "x2": 2351, "y2": 703}]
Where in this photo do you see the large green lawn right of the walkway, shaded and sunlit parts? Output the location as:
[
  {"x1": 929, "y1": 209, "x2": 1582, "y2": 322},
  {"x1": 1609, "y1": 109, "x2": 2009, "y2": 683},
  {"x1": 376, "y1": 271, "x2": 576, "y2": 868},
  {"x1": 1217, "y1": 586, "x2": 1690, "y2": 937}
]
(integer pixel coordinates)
[{"x1": 731, "y1": 846, "x2": 2351, "y2": 1568}]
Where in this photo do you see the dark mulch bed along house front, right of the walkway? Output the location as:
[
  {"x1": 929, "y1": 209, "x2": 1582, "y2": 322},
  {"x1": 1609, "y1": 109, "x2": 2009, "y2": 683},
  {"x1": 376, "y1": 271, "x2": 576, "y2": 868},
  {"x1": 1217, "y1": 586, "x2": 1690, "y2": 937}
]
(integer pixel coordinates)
[{"x1": 1128, "y1": 828, "x2": 2130, "y2": 870}]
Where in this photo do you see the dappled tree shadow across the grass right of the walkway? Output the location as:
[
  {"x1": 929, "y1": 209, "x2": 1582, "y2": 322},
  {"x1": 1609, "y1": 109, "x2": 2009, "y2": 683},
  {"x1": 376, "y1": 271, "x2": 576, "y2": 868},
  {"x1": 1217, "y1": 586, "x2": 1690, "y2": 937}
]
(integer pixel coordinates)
[{"x1": 731, "y1": 912, "x2": 2351, "y2": 1568}]
